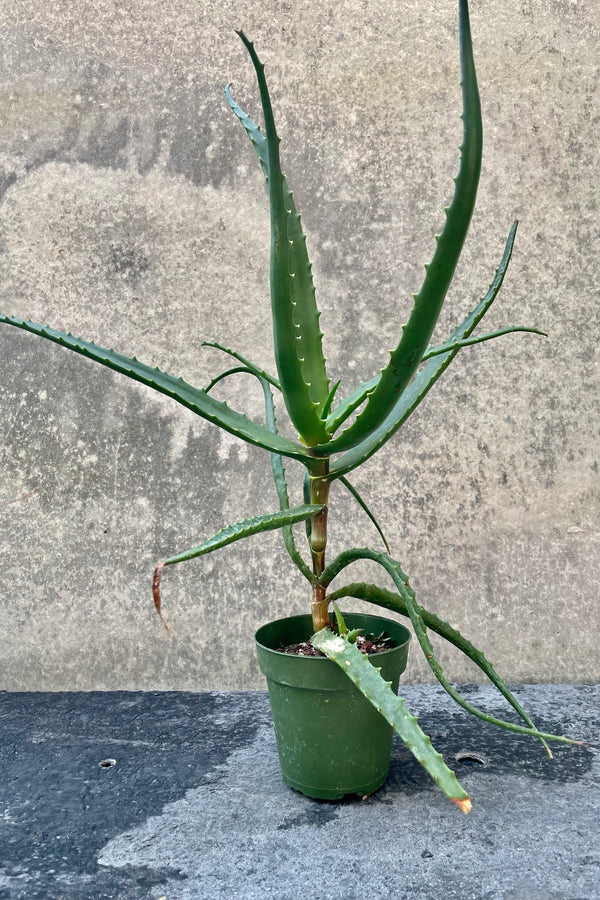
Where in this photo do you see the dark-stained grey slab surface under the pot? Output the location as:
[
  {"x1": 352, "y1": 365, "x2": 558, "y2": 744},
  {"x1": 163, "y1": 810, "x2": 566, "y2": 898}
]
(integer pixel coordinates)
[{"x1": 0, "y1": 685, "x2": 600, "y2": 900}]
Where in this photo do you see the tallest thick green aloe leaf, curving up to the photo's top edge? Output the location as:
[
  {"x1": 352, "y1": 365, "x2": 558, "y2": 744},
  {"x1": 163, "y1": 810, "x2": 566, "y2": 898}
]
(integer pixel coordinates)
[{"x1": 313, "y1": 0, "x2": 483, "y2": 456}]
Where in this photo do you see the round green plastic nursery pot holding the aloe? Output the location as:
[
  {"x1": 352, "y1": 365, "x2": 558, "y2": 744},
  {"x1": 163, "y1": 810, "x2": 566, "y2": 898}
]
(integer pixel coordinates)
[{"x1": 255, "y1": 613, "x2": 410, "y2": 800}]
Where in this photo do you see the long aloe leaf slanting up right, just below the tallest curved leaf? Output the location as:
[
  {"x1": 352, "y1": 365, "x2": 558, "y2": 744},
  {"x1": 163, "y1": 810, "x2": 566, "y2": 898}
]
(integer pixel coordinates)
[{"x1": 331, "y1": 222, "x2": 518, "y2": 478}]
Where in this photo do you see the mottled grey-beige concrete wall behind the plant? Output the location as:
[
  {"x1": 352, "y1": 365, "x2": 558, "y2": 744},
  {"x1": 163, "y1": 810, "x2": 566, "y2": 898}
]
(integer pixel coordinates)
[{"x1": 0, "y1": 0, "x2": 600, "y2": 690}]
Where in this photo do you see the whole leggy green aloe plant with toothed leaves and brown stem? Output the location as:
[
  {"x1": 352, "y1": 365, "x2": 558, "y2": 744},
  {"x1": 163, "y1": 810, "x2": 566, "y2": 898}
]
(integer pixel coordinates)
[{"x1": 0, "y1": 0, "x2": 576, "y2": 812}]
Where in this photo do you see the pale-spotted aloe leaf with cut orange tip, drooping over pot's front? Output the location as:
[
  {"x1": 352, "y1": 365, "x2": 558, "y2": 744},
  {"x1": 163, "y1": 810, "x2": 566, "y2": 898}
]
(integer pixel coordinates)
[{"x1": 311, "y1": 628, "x2": 471, "y2": 813}]
